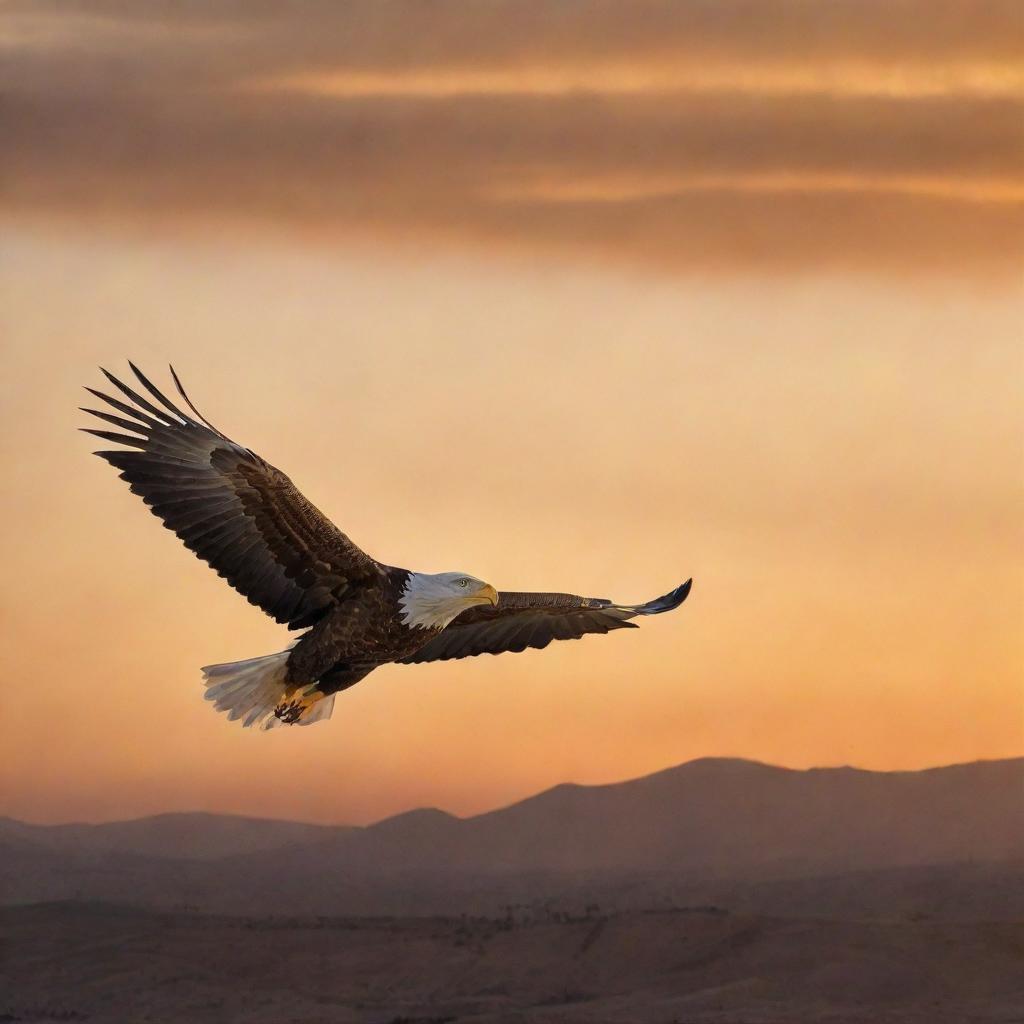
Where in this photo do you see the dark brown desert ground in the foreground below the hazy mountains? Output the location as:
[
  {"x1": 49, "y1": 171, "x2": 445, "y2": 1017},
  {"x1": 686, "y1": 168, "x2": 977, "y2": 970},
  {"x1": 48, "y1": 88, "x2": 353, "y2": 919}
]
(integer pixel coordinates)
[{"x1": 0, "y1": 902, "x2": 1024, "y2": 1024}]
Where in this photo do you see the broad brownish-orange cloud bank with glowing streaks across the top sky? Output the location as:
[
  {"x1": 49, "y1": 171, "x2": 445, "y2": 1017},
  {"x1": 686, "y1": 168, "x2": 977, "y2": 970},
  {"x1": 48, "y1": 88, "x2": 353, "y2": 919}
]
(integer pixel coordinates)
[{"x1": 6, "y1": 0, "x2": 1024, "y2": 275}]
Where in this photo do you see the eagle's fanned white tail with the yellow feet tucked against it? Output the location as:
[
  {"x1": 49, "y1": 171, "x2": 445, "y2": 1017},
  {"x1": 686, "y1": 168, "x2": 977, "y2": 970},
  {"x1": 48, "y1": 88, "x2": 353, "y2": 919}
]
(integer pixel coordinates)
[{"x1": 196, "y1": 650, "x2": 334, "y2": 729}]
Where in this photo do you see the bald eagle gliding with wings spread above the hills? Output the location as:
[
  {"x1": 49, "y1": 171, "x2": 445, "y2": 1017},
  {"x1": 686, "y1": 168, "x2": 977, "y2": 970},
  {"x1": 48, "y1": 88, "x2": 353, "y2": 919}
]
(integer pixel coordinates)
[{"x1": 82, "y1": 364, "x2": 690, "y2": 729}]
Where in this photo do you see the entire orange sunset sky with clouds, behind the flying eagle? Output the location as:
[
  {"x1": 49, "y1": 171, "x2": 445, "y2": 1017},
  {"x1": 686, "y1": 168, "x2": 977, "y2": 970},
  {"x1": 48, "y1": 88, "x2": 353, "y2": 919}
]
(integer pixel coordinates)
[{"x1": 0, "y1": 0, "x2": 1024, "y2": 822}]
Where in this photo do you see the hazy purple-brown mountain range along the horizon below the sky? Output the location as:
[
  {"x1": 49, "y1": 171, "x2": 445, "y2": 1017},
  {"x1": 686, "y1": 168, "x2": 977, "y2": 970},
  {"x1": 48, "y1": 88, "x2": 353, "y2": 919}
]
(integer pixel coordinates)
[{"x1": 0, "y1": 758, "x2": 1024, "y2": 912}]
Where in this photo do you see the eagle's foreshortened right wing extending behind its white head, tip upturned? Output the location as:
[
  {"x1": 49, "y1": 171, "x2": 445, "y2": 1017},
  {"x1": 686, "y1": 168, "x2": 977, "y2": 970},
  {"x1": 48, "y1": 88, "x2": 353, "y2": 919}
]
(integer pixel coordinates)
[{"x1": 401, "y1": 580, "x2": 692, "y2": 665}]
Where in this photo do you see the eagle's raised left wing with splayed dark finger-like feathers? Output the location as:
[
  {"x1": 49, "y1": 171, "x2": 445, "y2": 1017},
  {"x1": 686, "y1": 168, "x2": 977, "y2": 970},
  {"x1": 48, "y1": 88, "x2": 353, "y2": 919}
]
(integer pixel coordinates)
[{"x1": 83, "y1": 364, "x2": 383, "y2": 629}]
